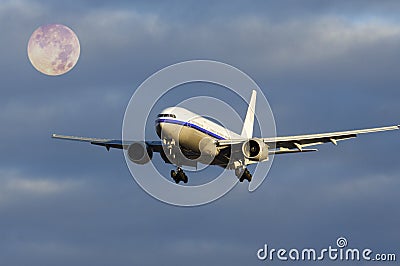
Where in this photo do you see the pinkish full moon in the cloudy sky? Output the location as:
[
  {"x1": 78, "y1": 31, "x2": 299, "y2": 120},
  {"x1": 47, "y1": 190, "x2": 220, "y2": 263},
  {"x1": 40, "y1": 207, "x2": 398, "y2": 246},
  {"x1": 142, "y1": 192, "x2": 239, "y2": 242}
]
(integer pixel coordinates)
[{"x1": 28, "y1": 24, "x2": 81, "y2": 76}]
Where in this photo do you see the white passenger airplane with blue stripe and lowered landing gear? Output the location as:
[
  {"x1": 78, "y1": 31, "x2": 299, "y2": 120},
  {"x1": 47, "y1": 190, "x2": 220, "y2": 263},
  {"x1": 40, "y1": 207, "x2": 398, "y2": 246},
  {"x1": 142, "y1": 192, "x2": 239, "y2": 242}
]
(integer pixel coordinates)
[{"x1": 52, "y1": 90, "x2": 400, "y2": 184}]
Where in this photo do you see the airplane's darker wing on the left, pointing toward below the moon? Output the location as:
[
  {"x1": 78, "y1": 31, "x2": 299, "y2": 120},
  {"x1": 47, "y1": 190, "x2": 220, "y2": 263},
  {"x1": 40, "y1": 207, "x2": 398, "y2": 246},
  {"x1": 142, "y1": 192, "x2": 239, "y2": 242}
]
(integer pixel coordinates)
[{"x1": 51, "y1": 134, "x2": 162, "y2": 152}]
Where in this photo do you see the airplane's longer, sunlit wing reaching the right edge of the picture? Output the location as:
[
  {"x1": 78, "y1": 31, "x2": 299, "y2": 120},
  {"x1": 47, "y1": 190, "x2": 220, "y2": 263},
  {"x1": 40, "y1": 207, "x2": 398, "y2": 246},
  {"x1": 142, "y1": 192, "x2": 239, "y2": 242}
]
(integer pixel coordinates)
[{"x1": 216, "y1": 125, "x2": 400, "y2": 154}]
